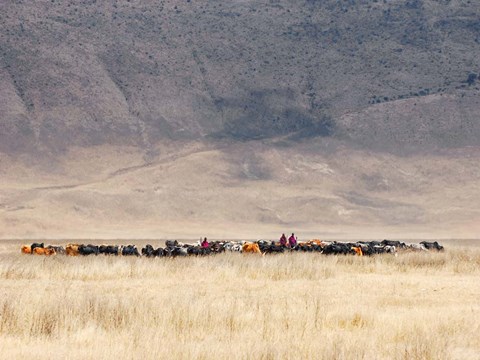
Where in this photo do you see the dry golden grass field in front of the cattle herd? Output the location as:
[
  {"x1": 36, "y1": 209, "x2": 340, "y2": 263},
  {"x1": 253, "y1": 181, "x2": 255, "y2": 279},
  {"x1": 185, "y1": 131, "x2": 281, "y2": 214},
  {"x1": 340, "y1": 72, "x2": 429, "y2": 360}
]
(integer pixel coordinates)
[{"x1": 0, "y1": 241, "x2": 480, "y2": 360}]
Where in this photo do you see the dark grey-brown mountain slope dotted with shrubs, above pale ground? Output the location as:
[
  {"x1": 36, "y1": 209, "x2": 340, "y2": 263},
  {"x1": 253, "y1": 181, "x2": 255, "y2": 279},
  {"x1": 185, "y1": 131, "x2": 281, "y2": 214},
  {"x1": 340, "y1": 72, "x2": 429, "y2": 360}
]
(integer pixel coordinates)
[{"x1": 0, "y1": 0, "x2": 480, "y2": 152}]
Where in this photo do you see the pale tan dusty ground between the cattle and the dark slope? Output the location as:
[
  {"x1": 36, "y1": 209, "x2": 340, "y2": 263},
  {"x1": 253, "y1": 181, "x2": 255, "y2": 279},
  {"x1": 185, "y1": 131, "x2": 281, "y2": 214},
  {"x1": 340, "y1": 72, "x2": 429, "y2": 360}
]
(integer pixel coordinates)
[{"x1": 0, "y1": 141, "x2": 480, "y2": 240}]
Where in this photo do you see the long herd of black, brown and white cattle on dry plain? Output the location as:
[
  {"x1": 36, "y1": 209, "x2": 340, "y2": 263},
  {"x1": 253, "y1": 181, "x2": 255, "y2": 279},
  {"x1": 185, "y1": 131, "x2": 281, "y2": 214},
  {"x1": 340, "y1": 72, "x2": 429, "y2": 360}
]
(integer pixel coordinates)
[{"x1": 21, "y1": 239, "x2": 443, "y2": 258}]
